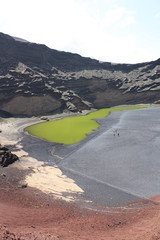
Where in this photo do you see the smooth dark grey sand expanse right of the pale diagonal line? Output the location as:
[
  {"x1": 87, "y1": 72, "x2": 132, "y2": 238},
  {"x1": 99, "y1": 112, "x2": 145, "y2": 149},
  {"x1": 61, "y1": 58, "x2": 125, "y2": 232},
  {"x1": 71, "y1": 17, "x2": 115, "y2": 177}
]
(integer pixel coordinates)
[{"x1": 61, "y1": 108, "x2": 160, "y2": 206}]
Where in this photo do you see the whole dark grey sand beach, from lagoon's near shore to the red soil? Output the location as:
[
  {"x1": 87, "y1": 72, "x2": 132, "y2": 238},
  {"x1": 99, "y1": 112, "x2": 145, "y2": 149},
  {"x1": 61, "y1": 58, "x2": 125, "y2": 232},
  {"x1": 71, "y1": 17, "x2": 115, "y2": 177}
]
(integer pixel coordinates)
[{"x1": 1, "y1": 108, "x2": 160, "y2": 206}]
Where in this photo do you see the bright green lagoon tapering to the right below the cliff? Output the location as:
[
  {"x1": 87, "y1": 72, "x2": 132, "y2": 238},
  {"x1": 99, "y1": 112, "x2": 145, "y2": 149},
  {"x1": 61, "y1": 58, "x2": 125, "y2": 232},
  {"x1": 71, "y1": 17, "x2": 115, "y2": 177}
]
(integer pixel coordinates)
[{"x1": 25, "y1": 105, "x2": 145, "y2": 144}]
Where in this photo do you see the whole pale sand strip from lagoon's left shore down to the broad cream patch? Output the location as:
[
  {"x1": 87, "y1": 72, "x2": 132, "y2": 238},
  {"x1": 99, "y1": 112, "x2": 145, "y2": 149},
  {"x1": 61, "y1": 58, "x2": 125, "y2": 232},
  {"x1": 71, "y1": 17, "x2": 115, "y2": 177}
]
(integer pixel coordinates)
[{"x1": 0, "y1": 116, "x2": 83, "y2": 201}]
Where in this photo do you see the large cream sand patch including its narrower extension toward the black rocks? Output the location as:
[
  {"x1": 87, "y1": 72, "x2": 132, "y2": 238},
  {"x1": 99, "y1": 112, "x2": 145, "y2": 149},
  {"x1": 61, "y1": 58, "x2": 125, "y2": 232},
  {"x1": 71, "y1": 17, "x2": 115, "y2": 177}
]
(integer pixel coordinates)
[{"x1": 14, "y1": 149, "x2": 84, "y2": 202}]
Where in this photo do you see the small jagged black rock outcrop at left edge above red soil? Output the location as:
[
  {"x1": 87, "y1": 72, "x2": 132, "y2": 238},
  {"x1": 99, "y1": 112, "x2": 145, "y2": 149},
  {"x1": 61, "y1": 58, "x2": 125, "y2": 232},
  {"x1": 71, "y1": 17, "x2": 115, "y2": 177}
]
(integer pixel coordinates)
[{"x1": 0, "y1": 146, "x2": 18, "y2": 167}]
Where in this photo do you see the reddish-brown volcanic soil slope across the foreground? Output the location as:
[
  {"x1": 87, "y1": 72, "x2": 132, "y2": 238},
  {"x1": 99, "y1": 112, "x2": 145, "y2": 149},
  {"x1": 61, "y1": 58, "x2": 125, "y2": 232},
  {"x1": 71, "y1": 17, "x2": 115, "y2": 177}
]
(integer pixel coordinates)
[{"x1": 0, "y1": 167, "x2": 160, "y2": 240}]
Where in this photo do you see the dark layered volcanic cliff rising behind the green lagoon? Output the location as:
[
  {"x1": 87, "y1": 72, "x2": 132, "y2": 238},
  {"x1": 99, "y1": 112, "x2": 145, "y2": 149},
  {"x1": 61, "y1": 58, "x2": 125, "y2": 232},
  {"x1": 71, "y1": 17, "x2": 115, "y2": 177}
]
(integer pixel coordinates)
[{"x1": 0, "y1": 33, "x2": 160, "y2": 116}]
